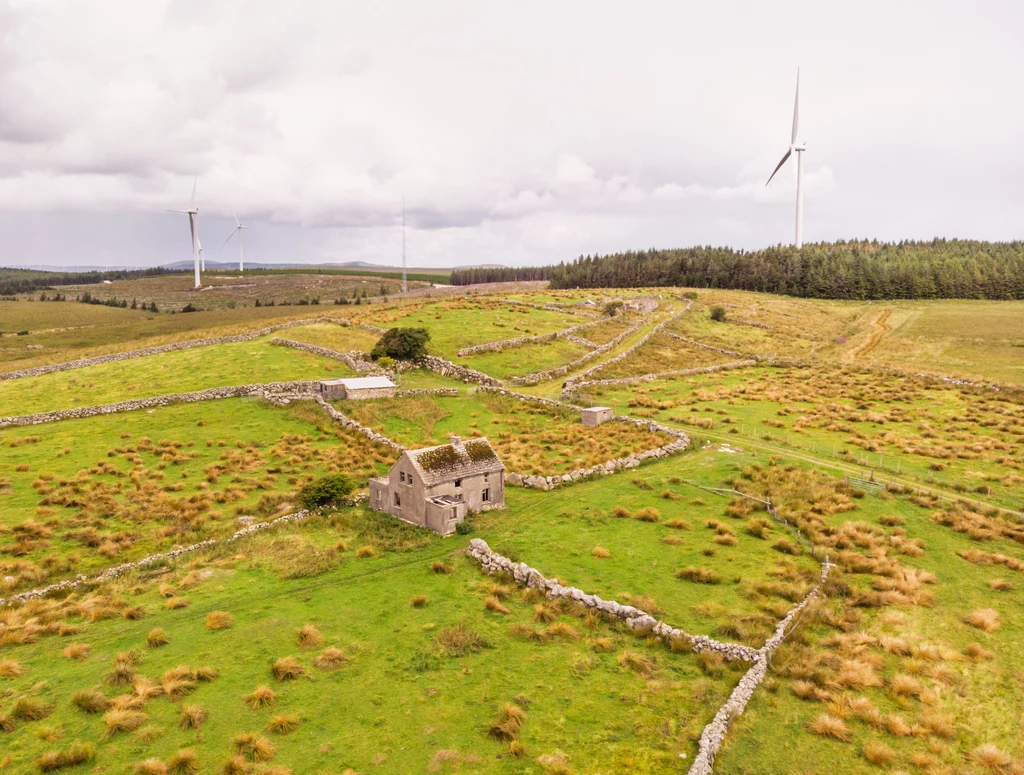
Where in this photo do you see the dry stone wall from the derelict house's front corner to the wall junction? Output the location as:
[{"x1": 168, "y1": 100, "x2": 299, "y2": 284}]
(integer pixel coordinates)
[{"x1": 466, "y1": 539, "x2": 758, "y2": 662}]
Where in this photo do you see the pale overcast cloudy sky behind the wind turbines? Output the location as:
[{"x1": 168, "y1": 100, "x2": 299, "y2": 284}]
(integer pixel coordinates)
[{"x1": 0, "y1": 0, "x2": 1024, "y2": 267}]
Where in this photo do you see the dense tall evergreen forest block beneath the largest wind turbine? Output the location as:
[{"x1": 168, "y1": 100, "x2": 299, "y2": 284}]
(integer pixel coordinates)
[{"x1": 548, "y1": 240, "x2": 1024, "y2": 299}]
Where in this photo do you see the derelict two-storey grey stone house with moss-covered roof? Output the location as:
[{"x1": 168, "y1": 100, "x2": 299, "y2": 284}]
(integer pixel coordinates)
[{"x1": 370, "y1": 436, "x2": 505, "y2": 535}]
